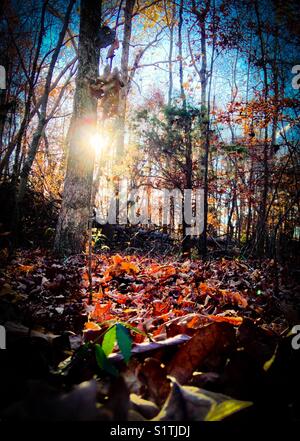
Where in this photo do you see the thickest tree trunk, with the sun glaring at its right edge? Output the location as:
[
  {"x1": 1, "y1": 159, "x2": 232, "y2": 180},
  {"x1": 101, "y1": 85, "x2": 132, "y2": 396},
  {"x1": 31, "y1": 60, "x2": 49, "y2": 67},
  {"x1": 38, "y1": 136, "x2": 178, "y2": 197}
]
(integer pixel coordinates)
[{"x1": 54, "y1": 0, "x2": 101, "y2": 256}]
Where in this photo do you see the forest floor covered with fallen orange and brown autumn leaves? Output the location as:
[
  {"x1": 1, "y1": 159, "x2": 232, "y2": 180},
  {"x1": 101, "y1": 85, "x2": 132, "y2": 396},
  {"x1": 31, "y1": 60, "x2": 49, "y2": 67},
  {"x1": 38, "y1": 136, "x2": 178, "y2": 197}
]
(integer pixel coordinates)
[{"x1": 0, "y1": 249, "x2": 300, "y2": 421}]
